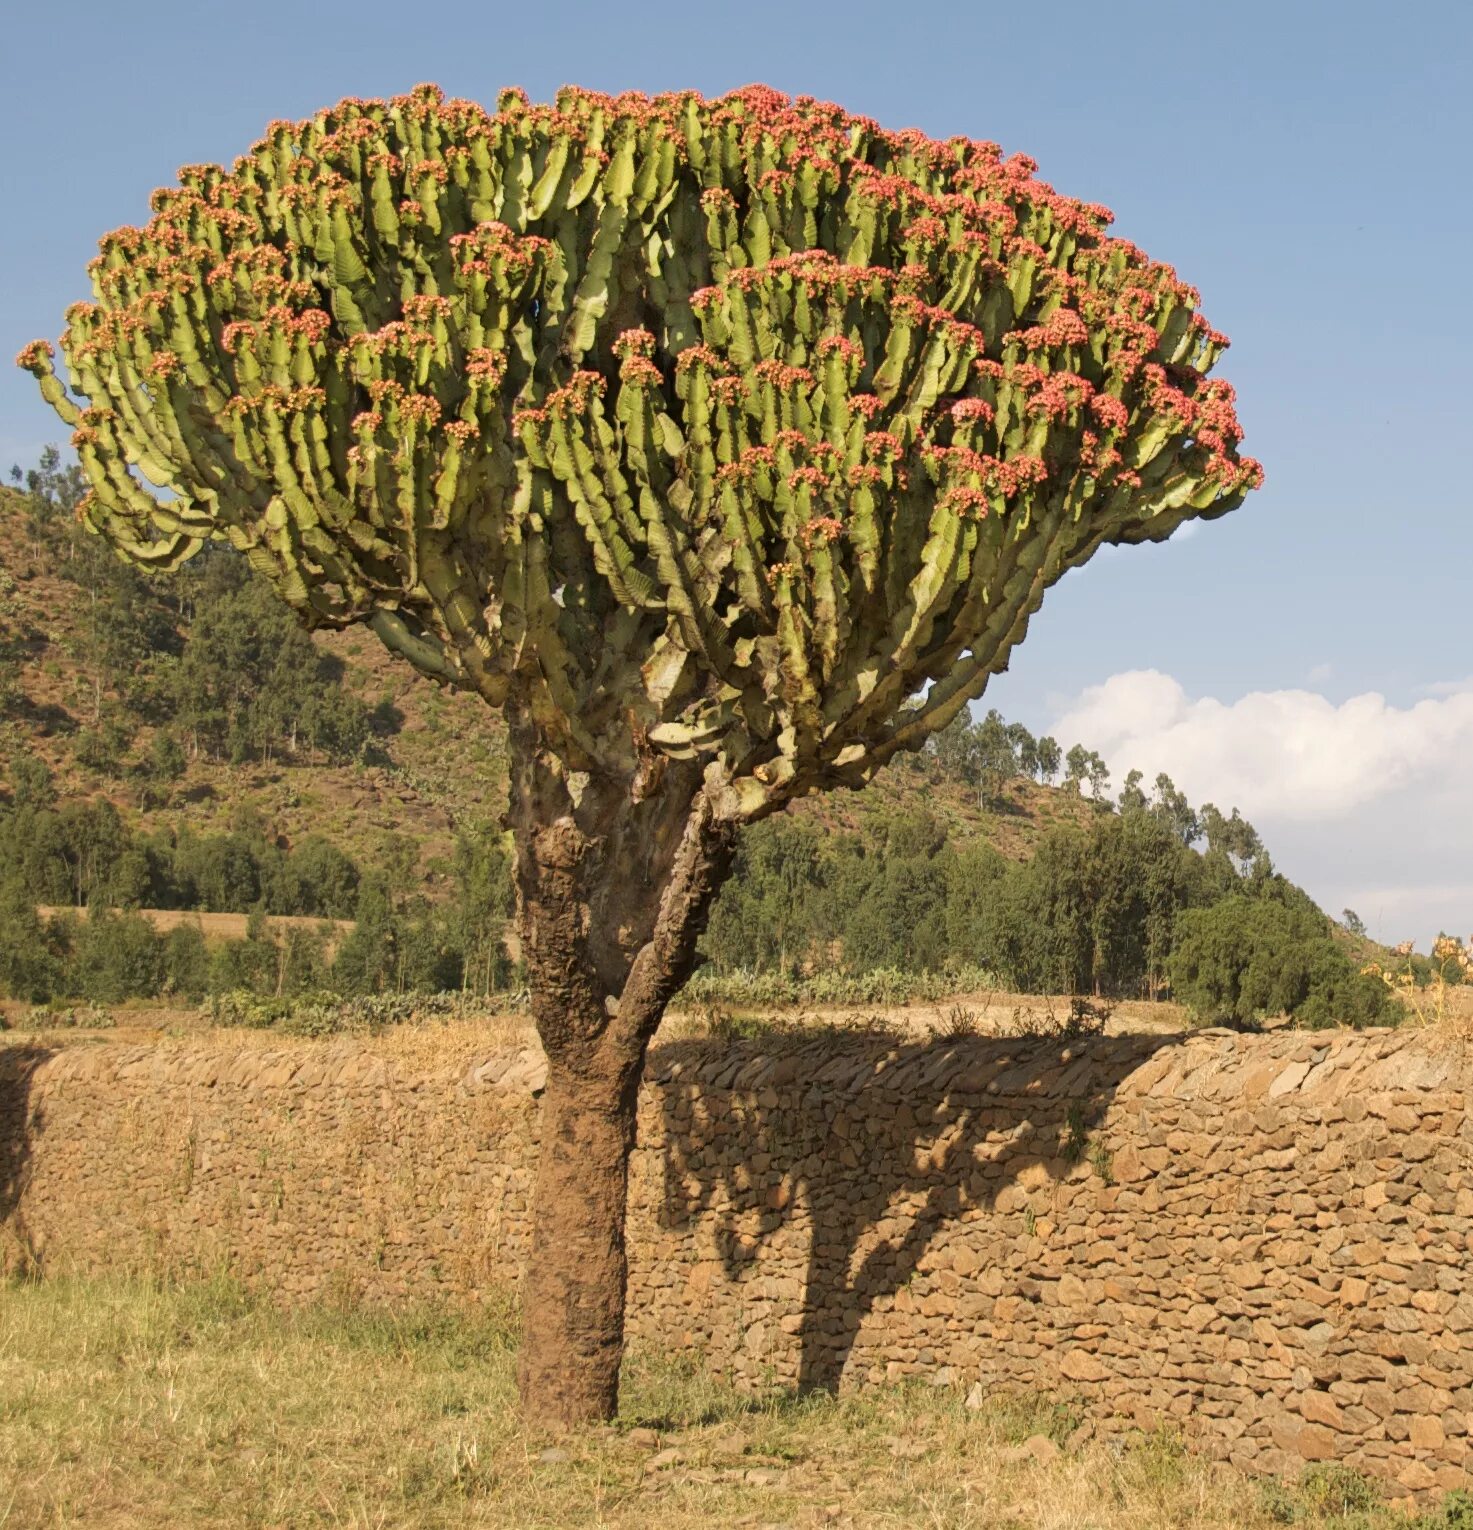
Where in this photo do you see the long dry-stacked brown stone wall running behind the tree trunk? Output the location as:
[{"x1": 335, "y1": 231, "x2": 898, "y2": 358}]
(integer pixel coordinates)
[{"x1": 0, "y1": 1033, "x2": 1473, "y2": 1490}]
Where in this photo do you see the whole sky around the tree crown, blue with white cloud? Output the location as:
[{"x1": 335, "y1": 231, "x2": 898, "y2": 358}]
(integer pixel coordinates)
[{"x1": 0, "y1": 0, "x2": 1473, "y2": 938}]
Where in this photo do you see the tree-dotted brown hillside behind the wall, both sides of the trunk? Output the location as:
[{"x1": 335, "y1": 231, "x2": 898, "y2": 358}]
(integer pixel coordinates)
[{"x1": 0, "y1": 471, "x2": 1406, "y2": 1024}]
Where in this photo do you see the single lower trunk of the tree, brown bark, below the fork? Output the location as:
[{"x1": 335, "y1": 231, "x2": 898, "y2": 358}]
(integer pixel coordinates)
[{"x1": 517, "y1": 1048, "x2": 642, "y2": 1427}]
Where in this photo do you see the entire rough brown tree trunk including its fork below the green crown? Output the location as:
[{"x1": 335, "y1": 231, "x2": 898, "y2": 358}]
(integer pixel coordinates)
[{"x1": 509, "y1": 712, "x2": 734, "y2": 1427}]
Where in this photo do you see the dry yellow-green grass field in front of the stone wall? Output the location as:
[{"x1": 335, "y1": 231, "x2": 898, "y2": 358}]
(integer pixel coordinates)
[{"x1": 0, "y1": 1281, "x2": 1473, "y2": 1530}]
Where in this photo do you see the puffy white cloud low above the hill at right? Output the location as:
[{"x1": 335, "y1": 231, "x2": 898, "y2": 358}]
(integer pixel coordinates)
[{"x1": 1049, "y1": 670, "x2": 1473, "y2": 939}]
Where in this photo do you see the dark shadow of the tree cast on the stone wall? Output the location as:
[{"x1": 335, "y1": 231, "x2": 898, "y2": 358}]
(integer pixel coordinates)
[{"x1": 650, "y1": 1034, "x2": 1181, "y2": 1394}]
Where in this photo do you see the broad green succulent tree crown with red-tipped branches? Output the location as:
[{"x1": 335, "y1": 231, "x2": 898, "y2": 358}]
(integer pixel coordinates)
[{"x1": 20, "y1": 87, "x2": 1260, "y2": 817}]
